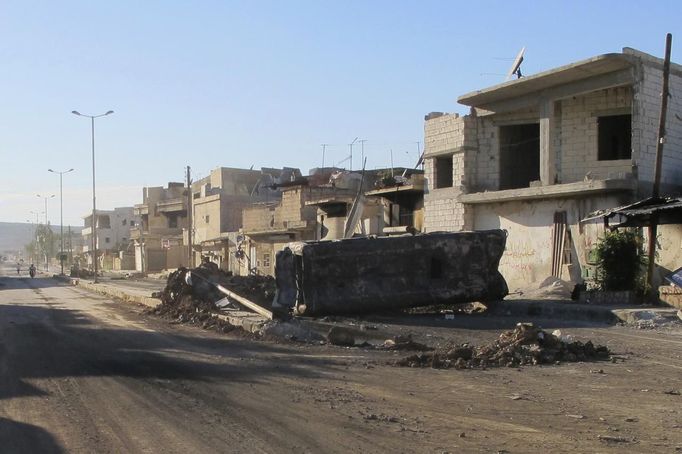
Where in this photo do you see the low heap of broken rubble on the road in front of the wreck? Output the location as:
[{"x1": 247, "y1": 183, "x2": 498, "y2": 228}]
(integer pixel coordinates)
[{"x1": 395, "y1": 323, "x2": 609, "y2": 369}]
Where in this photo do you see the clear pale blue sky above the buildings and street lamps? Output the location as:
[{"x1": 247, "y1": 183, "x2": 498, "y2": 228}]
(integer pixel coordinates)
[{"x1": 0, "y1": 0, "x2": 682, "y2": 225}]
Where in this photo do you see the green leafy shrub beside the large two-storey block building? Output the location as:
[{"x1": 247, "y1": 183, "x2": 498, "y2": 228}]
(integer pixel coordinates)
[{"x1": 595, "y1": 230, "x2": 647, "y2": 291}]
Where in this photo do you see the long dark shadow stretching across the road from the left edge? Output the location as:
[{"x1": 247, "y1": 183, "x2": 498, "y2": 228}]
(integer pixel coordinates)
[{"x1": 0, "y1": 304, "x2": 334, "y2": 399}]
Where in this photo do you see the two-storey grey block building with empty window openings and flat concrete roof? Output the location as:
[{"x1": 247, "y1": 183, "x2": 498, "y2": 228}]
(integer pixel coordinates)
[{"x1": 424, "y1": 48, "x2": 682, "y2": 289}]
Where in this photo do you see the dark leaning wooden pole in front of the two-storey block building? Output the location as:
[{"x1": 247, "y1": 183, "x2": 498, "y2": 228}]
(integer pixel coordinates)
[{"x1": 647, "y1": 33, "x2": 673, "y2": 295}]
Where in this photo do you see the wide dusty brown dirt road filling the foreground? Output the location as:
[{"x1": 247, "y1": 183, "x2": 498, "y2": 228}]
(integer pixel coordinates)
[{"x1": 0, "y1": 269, "x2": 682, "y2": 453}]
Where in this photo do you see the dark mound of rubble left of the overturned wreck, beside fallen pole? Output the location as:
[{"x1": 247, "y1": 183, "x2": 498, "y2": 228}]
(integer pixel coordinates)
[{"x1": 150, "y1": 262, "x2": 275, "y2": 331}]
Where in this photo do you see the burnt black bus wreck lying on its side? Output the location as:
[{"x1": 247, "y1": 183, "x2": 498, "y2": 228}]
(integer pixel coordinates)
[{"x1": 273, "y1": 230, "x2": 508, "y2": 315}]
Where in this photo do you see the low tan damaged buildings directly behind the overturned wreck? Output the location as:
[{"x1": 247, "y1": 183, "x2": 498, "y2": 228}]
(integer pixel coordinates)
[{"x1": 238, "y1": 168, "x2": 424, "y2": 275}]
